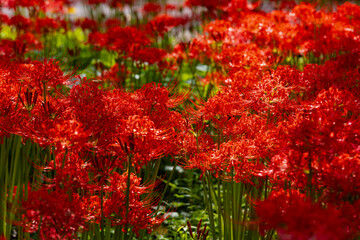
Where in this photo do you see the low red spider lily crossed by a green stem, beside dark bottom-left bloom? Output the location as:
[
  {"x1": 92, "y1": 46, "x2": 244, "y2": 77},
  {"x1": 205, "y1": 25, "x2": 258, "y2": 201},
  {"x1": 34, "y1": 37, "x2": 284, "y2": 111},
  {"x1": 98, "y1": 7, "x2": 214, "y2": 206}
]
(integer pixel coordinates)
[{"x1": 77, "y1": 172, "x2": 165, "y2": 235}]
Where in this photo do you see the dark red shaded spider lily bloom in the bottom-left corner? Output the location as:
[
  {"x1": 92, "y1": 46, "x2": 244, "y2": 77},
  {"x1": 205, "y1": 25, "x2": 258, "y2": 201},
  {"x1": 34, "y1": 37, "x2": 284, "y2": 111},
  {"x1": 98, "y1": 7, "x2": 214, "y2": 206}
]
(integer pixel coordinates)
[{"x1": 18, "y1": 189, "x2": 86, "y2": 239}]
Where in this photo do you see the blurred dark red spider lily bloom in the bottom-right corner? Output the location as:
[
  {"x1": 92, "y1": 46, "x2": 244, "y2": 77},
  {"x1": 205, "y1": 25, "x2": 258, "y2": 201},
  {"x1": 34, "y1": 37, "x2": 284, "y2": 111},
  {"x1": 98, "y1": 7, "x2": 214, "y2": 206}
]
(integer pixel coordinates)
[{"x1": 256, "y1": 190, "x2": 359, "y2": 240}]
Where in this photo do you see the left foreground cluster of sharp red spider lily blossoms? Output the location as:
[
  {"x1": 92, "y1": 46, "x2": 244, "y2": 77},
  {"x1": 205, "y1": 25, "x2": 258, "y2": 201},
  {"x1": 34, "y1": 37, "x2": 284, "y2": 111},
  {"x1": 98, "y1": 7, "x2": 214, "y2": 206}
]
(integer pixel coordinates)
[{"x1": 0, "y1": 57, "x2": 188, "y2": 239}]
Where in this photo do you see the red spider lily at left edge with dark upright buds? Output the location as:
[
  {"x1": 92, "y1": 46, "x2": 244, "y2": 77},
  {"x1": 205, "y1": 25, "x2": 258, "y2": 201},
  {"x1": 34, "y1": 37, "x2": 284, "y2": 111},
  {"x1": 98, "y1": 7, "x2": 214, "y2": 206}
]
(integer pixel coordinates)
[{"x1": 0, "y1": 58, "x2": 68, "y2": 138}]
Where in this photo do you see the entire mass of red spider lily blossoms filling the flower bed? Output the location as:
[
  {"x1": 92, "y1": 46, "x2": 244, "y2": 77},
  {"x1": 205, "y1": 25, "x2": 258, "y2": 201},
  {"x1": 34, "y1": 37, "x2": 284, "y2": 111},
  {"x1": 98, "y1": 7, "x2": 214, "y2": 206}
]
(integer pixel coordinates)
[{"x1": 0, "y1": 0, "x2": 360, "y2": 240}]
